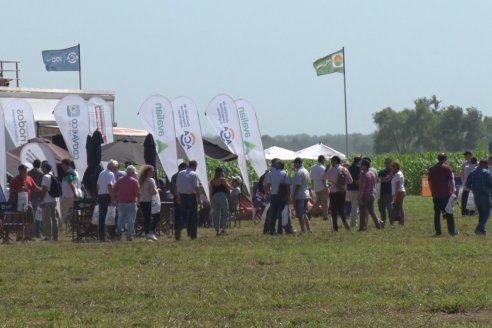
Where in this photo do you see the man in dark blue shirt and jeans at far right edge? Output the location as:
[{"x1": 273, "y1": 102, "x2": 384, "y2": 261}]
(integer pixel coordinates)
[{"x1": 466, "y1": 159, "x2": 492, "y2": 235}]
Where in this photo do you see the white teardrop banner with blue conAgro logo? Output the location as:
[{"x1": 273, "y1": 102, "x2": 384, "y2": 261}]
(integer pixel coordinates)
[{"x1": 53, "y1": 95, "x2": 90, "y2": 176}]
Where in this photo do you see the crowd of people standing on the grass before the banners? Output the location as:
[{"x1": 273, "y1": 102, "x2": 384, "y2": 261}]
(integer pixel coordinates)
[{"x1": 4, "y1": 147, "x2": 492, "y2": 241}]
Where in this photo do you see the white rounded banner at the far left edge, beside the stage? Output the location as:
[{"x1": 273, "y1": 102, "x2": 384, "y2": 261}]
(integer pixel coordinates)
[{"x1": 4, "y1": 99, "x2": 36, "y2": 147}]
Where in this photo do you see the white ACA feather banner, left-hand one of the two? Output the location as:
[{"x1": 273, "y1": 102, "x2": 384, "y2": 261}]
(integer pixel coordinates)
[{"x1": 172, "y1": 97, "x2": 210, "y2": 200}]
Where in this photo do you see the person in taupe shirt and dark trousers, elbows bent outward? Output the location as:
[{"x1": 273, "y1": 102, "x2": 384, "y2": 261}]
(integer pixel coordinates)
[{"x1": 323, "y1": 156, "x2": 353, "y2": 231}]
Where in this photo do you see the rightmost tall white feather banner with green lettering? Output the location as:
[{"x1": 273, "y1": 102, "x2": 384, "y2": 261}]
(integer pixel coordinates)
[{"x1": 236, "y1": 99, "x2": 267, "y2": 177}]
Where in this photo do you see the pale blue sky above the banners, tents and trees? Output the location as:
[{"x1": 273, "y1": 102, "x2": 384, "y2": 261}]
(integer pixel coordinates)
[{"x1": 0, "y1": 0, "x2": 492, "y2": 135}]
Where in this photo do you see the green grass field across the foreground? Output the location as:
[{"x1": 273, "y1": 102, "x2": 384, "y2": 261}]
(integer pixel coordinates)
[{"x1": 0, "y1": 196, "x2": 492, "y2": 327}]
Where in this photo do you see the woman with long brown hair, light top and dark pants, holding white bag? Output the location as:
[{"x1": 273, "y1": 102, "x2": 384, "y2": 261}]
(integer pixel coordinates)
[{"x1": 138, "y1": 165, "x2": 161, "y2": 241}]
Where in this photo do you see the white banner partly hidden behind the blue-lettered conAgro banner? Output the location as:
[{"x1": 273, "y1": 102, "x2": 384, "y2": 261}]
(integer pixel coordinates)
[{"x1": 87, "y1": 97, "x2": 114, "y2": 144}]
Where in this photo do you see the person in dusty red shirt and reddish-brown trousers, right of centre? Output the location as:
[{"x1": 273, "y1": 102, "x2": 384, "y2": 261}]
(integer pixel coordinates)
[{"x1": 359, "y1": 159, "x2": 383, "y2": 231}]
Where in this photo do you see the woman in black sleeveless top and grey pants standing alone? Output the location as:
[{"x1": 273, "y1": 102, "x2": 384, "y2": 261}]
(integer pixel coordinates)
[{"x1": 210, "y1": 167, "x2": 231, "y2": 236}]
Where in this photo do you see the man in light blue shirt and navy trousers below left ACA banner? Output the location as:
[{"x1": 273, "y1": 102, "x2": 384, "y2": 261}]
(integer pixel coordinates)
[{"x1": 176, "y1": 161, "x2": 200, "y2": 240}]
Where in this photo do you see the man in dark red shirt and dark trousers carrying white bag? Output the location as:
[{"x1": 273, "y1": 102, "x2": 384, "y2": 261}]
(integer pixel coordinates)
[{"x1": 428, "y1": 154, "x2": 458, "y2": 236}]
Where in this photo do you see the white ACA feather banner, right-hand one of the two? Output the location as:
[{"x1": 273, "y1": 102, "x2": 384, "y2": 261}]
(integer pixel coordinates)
[{"x1": 205, "y1": 94, "x2": 251, "y2": 194}]
